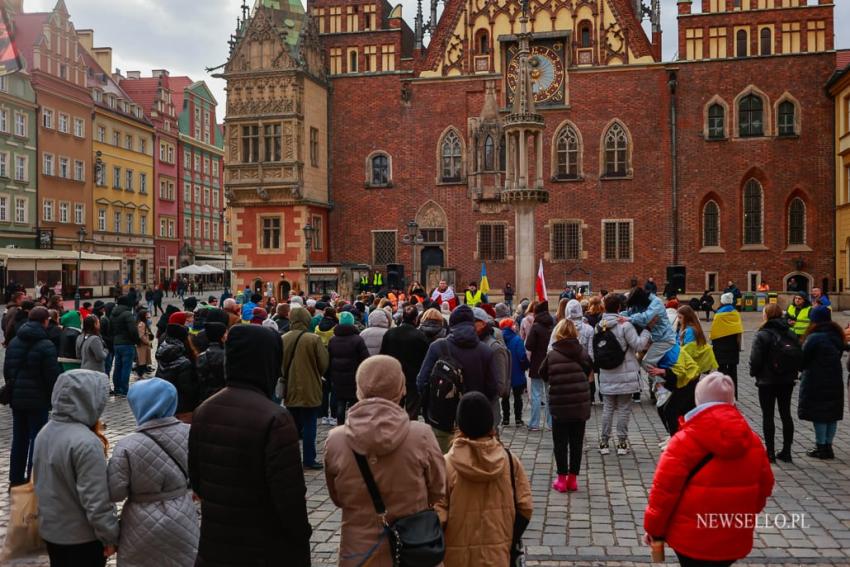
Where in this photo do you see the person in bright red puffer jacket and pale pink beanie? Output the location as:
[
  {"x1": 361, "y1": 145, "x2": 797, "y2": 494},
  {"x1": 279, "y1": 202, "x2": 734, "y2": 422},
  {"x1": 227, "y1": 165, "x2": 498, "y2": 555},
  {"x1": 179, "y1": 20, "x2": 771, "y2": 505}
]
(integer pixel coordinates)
[{"x1": 643, "y1": 372, "x2": 773, "y2": 567}]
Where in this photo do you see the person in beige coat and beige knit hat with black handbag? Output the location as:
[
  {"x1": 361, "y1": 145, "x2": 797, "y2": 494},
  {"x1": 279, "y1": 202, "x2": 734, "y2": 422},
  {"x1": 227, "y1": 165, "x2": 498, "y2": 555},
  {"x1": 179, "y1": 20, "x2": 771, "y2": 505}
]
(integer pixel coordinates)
[{"x1": 325, "y1": 355, "x2": 444, "y2": 567}]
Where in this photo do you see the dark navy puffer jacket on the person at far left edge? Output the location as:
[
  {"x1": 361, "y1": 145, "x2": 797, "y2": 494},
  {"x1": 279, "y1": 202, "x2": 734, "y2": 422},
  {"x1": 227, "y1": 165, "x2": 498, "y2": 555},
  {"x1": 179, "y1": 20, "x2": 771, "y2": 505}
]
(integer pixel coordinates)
[{"x1": 3, "y1": 321, "x2": 59, "y2": 410}]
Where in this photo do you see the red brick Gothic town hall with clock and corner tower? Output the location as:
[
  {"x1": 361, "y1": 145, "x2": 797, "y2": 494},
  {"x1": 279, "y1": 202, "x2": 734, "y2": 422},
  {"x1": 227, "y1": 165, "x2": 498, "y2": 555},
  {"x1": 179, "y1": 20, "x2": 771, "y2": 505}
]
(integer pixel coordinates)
[{"x1": 222, "y1": 0, "x2": 844, "y2": 302}]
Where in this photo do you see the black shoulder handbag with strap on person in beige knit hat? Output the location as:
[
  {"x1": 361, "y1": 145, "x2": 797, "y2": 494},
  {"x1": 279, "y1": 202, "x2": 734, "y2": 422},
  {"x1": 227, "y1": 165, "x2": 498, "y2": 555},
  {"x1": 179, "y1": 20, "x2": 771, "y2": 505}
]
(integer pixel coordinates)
[{"x1": 352, "y1": 451, "x2": 446, "y2": 567}]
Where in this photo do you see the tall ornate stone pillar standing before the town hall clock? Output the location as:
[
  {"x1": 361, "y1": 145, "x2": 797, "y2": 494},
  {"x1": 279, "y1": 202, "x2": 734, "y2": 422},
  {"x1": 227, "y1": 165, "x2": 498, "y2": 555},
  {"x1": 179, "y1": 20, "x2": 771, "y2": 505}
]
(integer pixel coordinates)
[{"x1": 502, "y1": 0, "x2": 549, "y2": 297}]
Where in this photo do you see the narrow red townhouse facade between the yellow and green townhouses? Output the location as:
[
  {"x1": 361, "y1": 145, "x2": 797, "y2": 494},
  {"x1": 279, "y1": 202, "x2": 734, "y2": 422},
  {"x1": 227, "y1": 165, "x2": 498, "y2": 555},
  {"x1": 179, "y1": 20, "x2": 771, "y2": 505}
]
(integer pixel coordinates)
[{"x1": 120, "y1": 69, "x2": 180, "y2": 284}]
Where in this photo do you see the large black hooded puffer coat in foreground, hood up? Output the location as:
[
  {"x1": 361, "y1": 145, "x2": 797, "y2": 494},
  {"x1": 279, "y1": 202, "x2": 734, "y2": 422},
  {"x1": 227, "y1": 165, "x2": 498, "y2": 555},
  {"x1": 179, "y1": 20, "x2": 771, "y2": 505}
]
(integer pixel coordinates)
[{"x1": 189, "y1": 326, "x2": 312, "y2": 567}]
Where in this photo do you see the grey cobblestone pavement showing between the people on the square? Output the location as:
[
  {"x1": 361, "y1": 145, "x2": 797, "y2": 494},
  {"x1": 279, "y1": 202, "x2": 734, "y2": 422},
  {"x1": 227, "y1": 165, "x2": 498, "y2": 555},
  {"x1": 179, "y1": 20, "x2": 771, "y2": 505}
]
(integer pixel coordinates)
[{"x1": 0, "y1": 314, "x2": 850, "y2": 566}]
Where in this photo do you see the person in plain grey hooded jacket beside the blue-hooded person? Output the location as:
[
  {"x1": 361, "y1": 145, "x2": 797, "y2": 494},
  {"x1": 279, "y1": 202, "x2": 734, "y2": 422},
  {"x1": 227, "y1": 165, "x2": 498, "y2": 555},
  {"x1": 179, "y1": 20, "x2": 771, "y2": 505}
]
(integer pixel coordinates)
[{"x1": 33, "y1": 369, "x2": 119, "y2": 567}]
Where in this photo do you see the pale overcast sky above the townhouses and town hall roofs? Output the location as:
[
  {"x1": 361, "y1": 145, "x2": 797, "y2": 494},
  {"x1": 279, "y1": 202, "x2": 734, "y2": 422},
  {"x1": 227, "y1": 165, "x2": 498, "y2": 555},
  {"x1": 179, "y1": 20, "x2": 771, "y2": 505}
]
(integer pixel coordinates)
[{"x1": 24, "y1": 0, "x2": 850, "y2": 114}]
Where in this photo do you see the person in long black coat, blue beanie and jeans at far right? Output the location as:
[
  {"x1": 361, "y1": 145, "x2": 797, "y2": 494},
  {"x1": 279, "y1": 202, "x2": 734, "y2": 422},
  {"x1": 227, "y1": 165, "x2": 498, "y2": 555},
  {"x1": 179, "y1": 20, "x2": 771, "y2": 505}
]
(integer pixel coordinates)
[{"x1": 797, "y1": 306, "x2": 847, "y2": 459}]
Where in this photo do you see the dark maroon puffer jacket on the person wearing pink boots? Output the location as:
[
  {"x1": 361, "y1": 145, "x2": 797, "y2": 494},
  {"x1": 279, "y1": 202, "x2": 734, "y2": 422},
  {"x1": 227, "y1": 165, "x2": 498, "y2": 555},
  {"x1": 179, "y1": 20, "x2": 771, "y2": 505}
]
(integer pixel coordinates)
[{"x1": 540, "y1": 339, "x2": 593, "y2": 421}]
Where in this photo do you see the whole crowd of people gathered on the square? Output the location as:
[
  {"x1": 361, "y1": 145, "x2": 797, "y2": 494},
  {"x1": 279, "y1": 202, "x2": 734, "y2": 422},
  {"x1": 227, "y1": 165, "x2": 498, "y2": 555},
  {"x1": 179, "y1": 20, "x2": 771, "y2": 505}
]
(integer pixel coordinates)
[{"x1": 0, "y1": 282, "x2": 848, "y2": 567}]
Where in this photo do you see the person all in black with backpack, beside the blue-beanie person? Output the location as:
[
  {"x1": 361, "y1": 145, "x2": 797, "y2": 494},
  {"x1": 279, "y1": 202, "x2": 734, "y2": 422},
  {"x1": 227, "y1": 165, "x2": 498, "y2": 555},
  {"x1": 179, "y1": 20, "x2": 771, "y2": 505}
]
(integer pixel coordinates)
[{"x1": 750, "y1": 303, "x2": 799, "y2": 463}]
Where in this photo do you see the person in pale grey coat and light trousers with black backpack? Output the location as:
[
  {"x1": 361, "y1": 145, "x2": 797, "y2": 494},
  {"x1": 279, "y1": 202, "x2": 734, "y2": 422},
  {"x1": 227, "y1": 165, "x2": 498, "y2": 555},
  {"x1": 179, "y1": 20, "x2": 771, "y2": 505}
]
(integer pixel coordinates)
[{"x1": 590, "y1": 293, "x2": 652, "y2": 455}]
